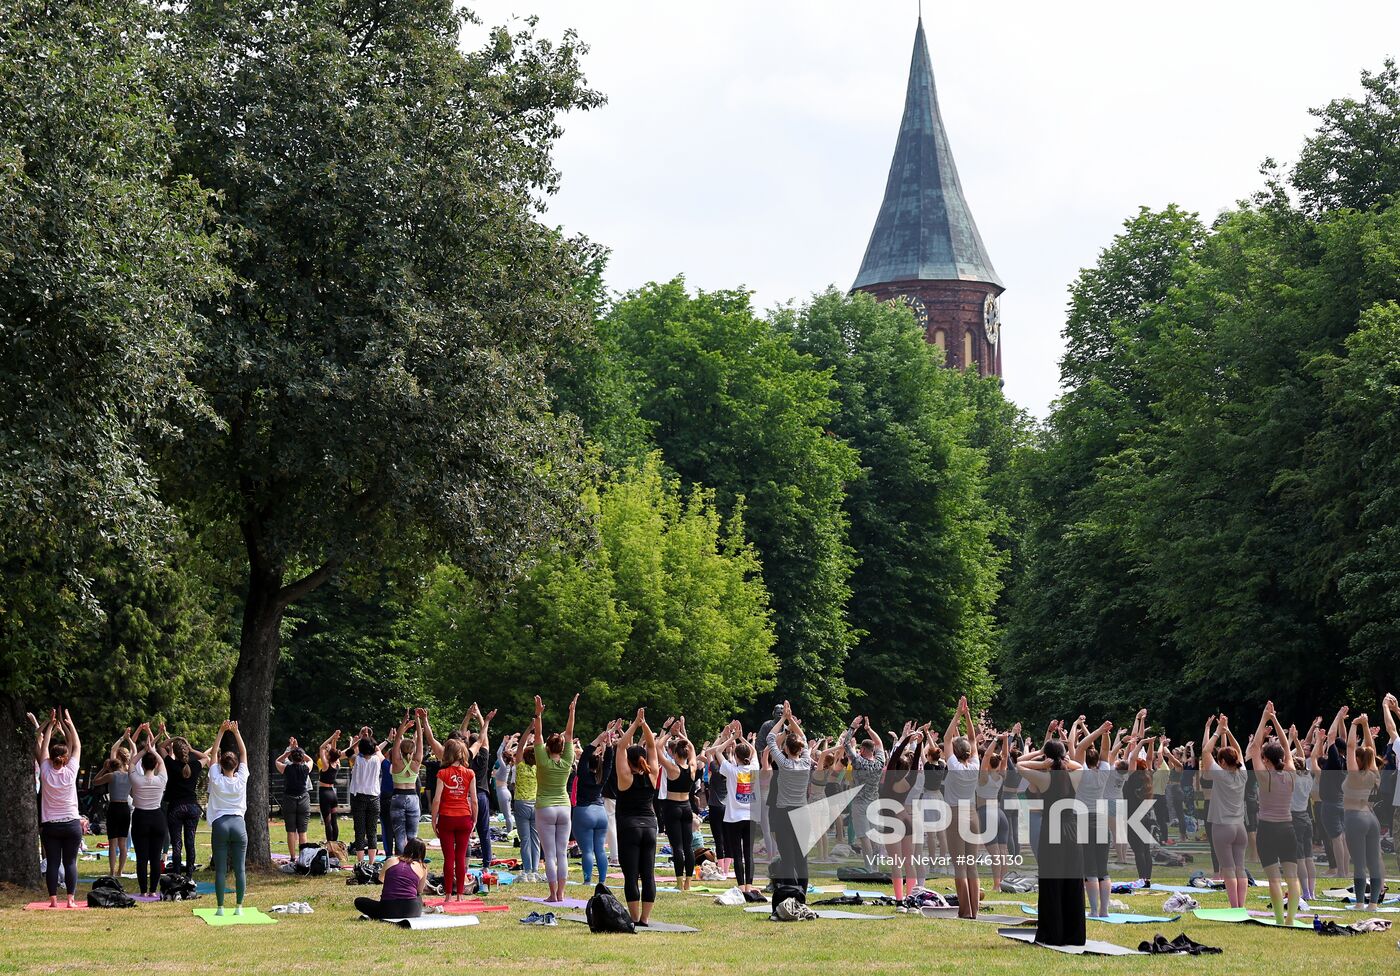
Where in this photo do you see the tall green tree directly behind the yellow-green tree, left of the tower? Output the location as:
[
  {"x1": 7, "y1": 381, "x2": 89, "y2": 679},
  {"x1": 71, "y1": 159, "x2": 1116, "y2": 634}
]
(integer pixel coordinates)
[{"x1": 599, "y1": 279, "x2": 858, "y2": 723}]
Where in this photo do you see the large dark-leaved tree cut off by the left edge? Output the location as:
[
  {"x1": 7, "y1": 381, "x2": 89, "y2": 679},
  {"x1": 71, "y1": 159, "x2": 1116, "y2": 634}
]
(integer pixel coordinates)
[{"x1": 0, "y1": 0, "x2": 224, "y2": 885}]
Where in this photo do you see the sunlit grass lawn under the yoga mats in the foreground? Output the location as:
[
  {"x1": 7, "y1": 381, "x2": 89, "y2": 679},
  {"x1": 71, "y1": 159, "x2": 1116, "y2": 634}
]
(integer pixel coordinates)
[{"x1": 0, "y1": 822, "x2": 1400, "y2": 976}]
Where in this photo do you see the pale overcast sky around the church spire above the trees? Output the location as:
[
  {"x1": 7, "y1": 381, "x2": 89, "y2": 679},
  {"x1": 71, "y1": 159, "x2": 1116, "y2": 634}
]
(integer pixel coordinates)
[{"x1": 466, "y1": 0, "x2": 1400, "y2": 416}]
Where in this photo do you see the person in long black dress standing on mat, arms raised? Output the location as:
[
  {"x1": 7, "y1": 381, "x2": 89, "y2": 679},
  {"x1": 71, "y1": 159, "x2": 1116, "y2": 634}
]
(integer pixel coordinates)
[{"x1": 1016, "y1": 738, "x2": 1085, "y2": 945}]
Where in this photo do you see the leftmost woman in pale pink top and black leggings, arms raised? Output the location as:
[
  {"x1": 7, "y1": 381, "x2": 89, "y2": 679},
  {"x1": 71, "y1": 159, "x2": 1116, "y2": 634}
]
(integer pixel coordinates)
[{"x1": 34, "y1": 709, "x2": 83, "y2": 909}]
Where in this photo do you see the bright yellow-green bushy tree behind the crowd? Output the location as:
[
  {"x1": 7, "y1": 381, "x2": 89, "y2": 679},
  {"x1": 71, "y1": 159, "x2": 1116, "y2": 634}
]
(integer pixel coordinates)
[{"x1": 410, "y1": 455, "x2": 776, "y2": 738}]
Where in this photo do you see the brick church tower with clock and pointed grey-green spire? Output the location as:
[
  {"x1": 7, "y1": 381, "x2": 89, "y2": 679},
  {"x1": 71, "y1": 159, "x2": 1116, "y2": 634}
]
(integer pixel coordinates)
[{"x1": 851, "y1": 18, "x2": 1005, "y2": 377}]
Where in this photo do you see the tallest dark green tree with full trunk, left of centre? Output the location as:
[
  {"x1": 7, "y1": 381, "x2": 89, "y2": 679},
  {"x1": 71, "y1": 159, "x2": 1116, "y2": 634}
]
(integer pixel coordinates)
[{"x1": 164, "y1": 0, "x2": 599, "y2": 864}]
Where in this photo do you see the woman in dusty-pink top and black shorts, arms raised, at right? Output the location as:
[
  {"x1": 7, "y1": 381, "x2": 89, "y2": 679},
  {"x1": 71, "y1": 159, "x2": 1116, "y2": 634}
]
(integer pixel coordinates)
[{"x1": 1249, "y1": 702, "x2": 1302, "y2": 926}]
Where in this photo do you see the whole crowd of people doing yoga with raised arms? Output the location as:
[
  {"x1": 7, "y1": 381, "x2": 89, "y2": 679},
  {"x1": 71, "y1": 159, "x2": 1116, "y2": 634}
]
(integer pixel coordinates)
[{"x1": 31, "y1": 695, "x2": 1400, "y2": 944}]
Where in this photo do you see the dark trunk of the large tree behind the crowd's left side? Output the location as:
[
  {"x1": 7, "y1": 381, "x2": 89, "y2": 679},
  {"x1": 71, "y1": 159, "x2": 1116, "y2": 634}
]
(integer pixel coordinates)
[{"x1": 229, "y1": 569, "x2": 286, "y2": 868}]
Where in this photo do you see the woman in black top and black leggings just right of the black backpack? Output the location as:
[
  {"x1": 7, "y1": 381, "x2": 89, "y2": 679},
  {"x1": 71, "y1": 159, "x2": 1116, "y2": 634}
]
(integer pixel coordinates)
[{"x1": 617, "y1": 709, "x2": 659, "y2": 926}]
